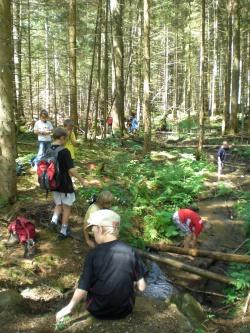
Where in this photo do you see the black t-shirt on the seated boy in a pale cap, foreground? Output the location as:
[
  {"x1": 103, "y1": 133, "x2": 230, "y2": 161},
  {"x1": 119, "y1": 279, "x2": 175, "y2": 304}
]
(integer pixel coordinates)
[{"x1": 78, "y1": 240, "x2": 146, "y2": 319}]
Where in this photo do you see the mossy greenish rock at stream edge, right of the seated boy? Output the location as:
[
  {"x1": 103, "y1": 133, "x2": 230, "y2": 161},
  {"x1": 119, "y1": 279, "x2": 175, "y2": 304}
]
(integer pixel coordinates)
[{"x1": 171, "y1": 293, "x2": 206, "y2": 328}]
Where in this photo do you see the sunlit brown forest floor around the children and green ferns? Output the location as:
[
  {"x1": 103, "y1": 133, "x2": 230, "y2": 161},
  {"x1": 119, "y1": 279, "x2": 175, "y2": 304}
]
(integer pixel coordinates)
[{"x1": 0, "y1": 134, "x2": 250, "y2": 333}]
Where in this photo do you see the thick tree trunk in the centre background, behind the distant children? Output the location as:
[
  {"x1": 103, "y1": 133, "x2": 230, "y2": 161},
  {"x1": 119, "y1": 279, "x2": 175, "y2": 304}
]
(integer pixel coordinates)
[{"x1": 110, "y1": 0, "x2": 124, "y2": 134}]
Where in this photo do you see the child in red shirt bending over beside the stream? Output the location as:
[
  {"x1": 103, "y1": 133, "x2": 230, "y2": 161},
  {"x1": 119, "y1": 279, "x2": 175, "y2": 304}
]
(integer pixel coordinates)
[{"x1": 173, "y1": 209, "x2": 208, "y2": 249}]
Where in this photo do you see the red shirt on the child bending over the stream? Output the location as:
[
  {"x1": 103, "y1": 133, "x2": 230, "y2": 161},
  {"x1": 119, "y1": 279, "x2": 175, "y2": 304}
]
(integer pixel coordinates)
[{"x1": 178, "y1": 209, "x2": 203, "y2": 237}]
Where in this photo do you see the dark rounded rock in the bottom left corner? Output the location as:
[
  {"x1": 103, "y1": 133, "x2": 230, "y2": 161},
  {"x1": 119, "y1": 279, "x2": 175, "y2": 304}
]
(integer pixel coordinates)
[{"x1": 0, "y1": 289, "x2": 28, "y2": 313}]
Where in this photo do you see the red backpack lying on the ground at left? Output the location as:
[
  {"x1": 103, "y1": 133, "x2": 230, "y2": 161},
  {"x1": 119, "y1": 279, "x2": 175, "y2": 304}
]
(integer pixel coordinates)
[{"x1": 8, "y1": 216, "x2": 36, "y2": 243}]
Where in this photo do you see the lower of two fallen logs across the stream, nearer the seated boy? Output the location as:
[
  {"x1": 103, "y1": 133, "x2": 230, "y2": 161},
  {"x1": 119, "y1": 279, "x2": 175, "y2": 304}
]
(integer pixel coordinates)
[{"x1": 137, "y1": 249, "x2": 234, "y2": 284}]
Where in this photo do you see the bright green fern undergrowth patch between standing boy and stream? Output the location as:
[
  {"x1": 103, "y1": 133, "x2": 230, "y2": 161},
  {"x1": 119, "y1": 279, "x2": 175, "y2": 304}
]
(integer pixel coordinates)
[{"x1": 80, "y1": 141, "x2": 209, "y2": 247}]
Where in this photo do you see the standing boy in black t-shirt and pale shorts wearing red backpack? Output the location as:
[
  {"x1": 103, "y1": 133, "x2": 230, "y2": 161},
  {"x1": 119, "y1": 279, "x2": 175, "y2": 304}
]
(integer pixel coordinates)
[{"x1": 37, "y1": 128, "x2": 86, "y2": 238}]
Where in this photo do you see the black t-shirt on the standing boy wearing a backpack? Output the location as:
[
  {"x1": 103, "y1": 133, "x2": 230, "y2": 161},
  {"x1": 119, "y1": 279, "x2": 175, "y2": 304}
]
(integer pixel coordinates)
[{"x1": 51, "y1": 145, "x2": 74, "y2": 193}]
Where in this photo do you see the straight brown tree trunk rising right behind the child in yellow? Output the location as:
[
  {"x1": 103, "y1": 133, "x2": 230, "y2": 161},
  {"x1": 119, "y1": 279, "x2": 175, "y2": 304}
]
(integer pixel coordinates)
[{"x1": 69, "y1": 0, "x2": 78, "y2": 128}]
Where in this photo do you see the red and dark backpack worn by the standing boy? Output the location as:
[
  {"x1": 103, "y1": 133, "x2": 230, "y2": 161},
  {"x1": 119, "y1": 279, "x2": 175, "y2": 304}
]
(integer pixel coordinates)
[{"x1": 37, "y1": 146, "x2": 65, "y2": 192}]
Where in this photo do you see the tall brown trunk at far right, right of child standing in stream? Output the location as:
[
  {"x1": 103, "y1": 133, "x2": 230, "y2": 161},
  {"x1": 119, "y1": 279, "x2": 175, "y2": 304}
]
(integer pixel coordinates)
[{"x1": 230, "y1": 0, "x2": 240, "y2": 134}]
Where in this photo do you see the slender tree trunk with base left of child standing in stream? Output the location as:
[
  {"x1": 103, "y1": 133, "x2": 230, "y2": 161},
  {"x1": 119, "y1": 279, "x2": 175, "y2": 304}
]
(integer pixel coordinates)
[{"x1": 198, "y1": 0, "x2": 207, "y2": 154}]
